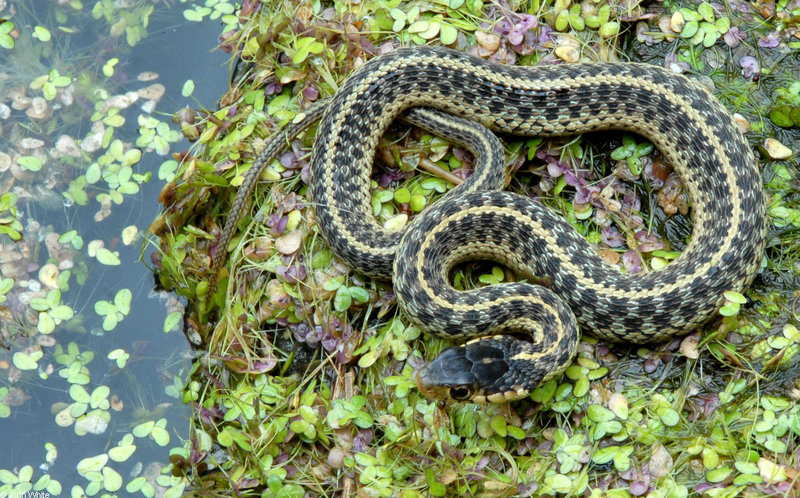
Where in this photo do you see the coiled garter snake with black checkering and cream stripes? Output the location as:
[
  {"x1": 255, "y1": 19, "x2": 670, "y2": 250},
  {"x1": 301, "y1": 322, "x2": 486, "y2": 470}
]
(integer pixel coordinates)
[{"x1": 216, "y1": 47, "x2": 766, "y2": 402}]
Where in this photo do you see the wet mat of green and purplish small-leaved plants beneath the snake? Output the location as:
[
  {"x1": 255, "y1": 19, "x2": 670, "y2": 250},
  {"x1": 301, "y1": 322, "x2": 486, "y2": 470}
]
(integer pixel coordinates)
[{"x1": 145, "y1": 0, "x2": 800, "y2": 497}]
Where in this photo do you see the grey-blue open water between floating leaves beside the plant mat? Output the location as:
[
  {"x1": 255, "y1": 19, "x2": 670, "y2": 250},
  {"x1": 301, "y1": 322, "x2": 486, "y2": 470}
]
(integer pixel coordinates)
[{"x1": 0, "y1": 1, "x2": 229, "y2": 496}]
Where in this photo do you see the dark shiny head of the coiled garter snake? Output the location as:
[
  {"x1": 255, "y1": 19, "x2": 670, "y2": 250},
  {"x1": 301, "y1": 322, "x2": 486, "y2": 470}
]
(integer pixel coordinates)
[{"x1": 415, "y1": 336, "x2": 528, "y2": 403}]
